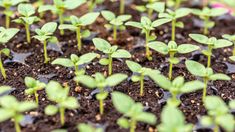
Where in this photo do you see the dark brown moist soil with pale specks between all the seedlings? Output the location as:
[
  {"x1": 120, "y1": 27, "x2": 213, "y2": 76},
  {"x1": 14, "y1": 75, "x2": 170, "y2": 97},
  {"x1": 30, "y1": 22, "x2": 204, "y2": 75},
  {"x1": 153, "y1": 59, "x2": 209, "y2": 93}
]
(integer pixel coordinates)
[{"x1": 0, "y1": 0, "x2": 235, "y2": 132}]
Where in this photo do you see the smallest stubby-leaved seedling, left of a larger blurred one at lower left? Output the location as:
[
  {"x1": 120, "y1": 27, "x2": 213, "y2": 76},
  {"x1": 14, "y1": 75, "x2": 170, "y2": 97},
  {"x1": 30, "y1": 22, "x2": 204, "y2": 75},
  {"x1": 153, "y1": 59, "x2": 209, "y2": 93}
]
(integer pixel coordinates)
[{"x1": 24, "y1": 77, "x2": 46, "y2": 104}]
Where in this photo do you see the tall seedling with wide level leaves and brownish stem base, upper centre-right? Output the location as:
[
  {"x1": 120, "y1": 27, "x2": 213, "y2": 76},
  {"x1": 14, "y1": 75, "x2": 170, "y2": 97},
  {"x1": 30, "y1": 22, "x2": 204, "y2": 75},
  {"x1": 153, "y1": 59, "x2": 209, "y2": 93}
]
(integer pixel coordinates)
[{"x1": 125, "y1": 16, "x2": 169, "y2": 60}]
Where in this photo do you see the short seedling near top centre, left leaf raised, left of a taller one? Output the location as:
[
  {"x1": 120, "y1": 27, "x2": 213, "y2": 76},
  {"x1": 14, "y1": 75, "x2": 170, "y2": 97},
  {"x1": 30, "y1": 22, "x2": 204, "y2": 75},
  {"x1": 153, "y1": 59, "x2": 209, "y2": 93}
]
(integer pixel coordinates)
[{"x1": 101, "y1": 11, "x2": 131, "y2": 41}]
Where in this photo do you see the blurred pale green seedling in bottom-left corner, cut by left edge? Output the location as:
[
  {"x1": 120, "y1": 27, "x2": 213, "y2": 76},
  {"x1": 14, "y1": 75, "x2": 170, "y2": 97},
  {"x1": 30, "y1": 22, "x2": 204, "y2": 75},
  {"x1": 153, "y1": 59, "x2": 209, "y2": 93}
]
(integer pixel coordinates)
[{"x1": 0, "y1": 96, "x2": 37, "y2": 132}]
